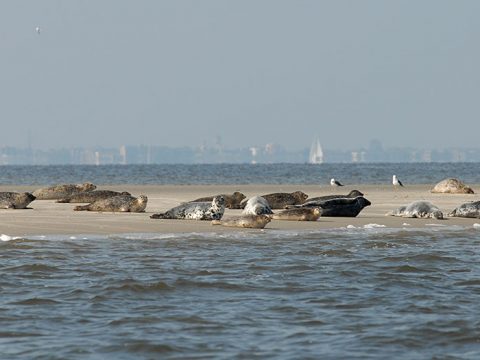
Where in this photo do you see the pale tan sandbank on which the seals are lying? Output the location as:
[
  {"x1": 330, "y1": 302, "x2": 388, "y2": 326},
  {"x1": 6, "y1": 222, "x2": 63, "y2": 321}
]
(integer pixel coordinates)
[{"x1": 0, "y1": 184, "x2": 480, "y2": 236}]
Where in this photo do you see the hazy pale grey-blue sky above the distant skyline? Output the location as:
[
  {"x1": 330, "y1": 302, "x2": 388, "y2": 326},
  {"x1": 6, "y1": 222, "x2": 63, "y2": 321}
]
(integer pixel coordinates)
[{"x1": 0, "y1": 0, "x2": 480, "y2": 150}]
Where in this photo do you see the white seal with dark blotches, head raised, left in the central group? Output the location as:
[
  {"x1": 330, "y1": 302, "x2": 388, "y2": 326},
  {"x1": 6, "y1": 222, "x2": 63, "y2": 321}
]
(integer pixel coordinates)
[{"x1": 150, "y1": 196, "x2": 225, "y2": 220}]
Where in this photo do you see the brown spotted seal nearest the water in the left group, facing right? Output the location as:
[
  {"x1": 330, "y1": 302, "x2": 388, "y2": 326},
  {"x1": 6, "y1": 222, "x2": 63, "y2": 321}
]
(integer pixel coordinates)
[{"x1": 73, "y1": 195, "x2": 148, "y2": 212}]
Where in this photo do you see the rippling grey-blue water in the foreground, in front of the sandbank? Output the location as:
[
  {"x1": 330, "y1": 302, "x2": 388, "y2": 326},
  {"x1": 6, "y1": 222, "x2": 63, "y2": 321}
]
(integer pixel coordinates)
[{"x1": 0, "y1": 225, "x2": 480, "y2": 359}]
